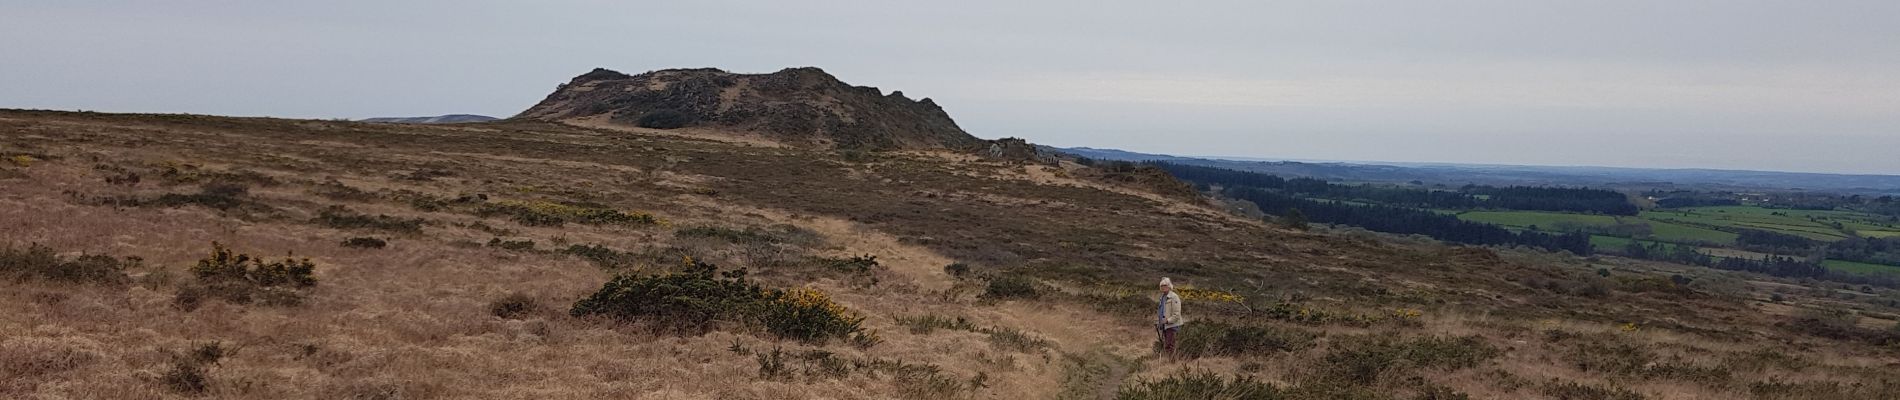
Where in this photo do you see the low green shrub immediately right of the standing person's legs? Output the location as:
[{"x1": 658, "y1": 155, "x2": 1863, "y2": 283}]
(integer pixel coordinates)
[{"x1": 1174, "y1": 320, "x2": 1319, "y2": 358}]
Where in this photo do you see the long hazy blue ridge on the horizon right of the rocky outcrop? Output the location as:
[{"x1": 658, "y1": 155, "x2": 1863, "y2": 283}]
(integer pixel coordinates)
[{"x1": 1049, "y1": 148, "x2": 1900, "y2": 195}]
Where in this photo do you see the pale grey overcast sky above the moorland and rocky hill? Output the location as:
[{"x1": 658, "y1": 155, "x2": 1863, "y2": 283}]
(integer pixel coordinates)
[{"x1": 0, "y1": 0, "x2": 1900, "y2": 174}]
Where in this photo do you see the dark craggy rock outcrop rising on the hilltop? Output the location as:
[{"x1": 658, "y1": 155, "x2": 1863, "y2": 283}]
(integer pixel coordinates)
[{"x1": 517, "y1": 68, "x2": 988, "y2": 152}]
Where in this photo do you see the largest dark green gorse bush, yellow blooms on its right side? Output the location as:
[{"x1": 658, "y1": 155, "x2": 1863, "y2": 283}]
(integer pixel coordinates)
[{"x1": 570, "y1": 258, "x2": 865, "y2": 343}]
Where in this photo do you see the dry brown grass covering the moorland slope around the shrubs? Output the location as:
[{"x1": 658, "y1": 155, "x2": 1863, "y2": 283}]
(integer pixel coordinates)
[{"x1": 0, "y1": 112, "x2": 1900, "y2": 398}]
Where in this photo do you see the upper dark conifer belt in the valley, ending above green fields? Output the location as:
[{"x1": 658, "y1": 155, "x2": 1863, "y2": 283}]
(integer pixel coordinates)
[{"x1": 1148, "y1": 161, "x2": 1640, "y2": 216}]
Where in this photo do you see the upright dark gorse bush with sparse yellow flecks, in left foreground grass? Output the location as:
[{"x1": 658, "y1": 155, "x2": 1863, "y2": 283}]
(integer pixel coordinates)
[{"x1": 173, "y1": 243, "x2": 317, "y2": 309}]
